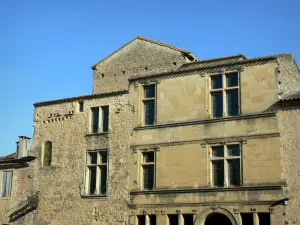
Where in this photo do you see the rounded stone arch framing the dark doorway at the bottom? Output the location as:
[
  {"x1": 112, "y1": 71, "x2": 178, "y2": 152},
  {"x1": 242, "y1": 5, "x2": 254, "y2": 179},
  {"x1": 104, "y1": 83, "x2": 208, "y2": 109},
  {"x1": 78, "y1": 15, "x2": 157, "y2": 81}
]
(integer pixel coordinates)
[{"x1": 195, "y1": 207, "x2": 237, "y2": 225}]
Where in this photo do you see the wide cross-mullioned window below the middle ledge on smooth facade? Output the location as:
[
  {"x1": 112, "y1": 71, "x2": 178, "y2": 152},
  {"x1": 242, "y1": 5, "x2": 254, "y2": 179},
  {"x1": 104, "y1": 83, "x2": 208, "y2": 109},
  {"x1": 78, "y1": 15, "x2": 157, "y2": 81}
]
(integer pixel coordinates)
[{"x1": 211, "y1": 144, "x2": 241, "y2": 187}]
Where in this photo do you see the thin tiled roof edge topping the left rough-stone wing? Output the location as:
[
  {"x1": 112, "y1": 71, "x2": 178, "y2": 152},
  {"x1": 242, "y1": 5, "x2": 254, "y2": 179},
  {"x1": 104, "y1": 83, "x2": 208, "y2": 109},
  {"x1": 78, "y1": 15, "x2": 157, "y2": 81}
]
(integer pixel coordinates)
[{"x1": 33, "y1": 89, "x2": 128, "y2": 107}]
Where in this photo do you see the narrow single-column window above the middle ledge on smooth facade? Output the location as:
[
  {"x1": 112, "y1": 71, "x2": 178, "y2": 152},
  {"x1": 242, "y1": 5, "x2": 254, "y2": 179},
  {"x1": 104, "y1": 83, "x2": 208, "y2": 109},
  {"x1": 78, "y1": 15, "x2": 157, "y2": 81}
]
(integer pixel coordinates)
[{"x1": 142, "y1": 84, "x2": 156, "y2": 125}]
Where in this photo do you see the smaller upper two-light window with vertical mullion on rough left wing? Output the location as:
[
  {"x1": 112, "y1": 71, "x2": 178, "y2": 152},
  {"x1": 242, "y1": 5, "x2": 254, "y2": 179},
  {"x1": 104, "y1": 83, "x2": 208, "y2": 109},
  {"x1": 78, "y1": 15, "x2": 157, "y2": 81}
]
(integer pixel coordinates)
[{"x1": 91, "y1": 106, "x2": 109, "y2": 133}]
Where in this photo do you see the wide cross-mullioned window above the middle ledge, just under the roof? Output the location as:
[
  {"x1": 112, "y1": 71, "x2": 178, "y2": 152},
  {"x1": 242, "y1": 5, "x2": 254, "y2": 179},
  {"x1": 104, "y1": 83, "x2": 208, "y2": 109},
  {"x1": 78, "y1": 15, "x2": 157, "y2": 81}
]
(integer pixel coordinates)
[{"x1": 210, "y1": 72, "x2": 240, "y2": 118}]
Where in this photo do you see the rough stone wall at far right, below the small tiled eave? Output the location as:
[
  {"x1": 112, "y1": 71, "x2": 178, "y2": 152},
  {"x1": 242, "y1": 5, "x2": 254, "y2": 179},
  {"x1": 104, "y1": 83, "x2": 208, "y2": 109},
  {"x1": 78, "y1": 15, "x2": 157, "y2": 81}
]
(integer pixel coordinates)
[{"x1": 277, "y1": 106, "x2": 300, "y2": 224}]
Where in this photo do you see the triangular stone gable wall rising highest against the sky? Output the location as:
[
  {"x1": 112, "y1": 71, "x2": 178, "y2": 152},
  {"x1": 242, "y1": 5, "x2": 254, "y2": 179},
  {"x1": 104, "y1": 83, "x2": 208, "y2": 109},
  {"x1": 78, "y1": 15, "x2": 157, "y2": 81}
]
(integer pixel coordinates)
[{"x1": 93, "y1": 39, "x2": 190, "y2": 93}]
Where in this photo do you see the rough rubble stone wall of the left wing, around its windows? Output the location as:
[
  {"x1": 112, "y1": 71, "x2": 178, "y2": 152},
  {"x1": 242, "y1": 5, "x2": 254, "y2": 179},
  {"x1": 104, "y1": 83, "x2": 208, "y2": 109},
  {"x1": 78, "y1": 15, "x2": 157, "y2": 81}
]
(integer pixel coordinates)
[{"x1": 29, "y1": 92, "x2": 132, "y2": 225}]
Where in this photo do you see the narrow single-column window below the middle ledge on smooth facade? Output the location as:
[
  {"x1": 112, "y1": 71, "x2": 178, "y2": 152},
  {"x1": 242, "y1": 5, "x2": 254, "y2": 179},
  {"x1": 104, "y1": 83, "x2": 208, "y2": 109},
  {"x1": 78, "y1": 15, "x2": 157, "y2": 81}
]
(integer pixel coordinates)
[{"x1": 141, "y1": 151, "x2": 155, "y2": 190}]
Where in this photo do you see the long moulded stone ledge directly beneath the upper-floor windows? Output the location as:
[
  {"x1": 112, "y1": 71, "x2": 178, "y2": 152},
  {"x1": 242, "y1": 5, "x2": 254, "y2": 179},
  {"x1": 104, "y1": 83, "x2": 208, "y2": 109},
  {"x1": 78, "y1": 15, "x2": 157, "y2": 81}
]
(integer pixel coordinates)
[{"x1": 133, "y1": 112, "x2": 276, "y2": 131}]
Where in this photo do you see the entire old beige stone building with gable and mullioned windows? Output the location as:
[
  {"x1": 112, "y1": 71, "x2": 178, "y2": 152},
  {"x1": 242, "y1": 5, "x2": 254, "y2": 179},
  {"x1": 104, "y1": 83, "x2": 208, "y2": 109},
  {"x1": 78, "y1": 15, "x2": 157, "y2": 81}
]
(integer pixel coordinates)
[{"x1": 1, "y1": 37, "x2": 300, "y2": 225}]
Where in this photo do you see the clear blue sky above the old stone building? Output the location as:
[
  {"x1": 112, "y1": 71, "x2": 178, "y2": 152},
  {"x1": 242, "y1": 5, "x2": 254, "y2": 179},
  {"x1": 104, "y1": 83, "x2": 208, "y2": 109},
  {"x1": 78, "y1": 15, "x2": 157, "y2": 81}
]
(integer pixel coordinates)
[{"x1": 0, "y1": 0, "x2": 300, "y2": 155}]
